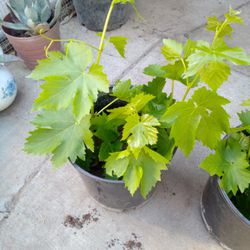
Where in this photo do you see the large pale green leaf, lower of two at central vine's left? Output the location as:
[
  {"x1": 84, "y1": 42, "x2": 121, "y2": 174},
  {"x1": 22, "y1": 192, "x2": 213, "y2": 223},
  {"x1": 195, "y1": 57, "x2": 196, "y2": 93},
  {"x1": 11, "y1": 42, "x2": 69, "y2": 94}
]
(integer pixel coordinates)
[{"x1": 25, "y1": 109, "x2": 94, "y2": 167}]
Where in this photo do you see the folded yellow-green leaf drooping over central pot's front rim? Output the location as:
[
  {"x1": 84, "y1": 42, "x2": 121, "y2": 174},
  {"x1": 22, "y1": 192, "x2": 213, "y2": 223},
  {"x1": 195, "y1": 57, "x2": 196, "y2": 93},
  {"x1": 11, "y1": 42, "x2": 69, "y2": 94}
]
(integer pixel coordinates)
[{"x1": 105, "y1": 147, "x2": 168, "y2": 198}]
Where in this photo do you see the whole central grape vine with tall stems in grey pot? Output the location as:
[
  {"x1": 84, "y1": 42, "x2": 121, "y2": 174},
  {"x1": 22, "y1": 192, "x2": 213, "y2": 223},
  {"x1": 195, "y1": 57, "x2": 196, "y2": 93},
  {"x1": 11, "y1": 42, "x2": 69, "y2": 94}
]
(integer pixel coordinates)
[{"x1": 25, "y1": 0, "x2": 250, "y2": 213}]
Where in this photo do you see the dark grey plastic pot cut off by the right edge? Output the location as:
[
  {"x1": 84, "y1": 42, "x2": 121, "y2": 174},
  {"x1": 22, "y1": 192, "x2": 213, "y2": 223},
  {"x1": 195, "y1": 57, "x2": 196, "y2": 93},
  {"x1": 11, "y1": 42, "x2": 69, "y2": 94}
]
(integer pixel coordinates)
[{"x1": 201, "y1": 177, "x2": 250, "y2": 250}]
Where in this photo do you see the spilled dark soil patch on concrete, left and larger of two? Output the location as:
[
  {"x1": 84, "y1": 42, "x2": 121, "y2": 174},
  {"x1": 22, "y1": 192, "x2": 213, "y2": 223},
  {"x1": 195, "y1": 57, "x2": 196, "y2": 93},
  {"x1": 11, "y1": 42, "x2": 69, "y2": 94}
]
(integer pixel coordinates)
[{"x1": 63, "y1": 208, "x2": 100, "y2": 229}]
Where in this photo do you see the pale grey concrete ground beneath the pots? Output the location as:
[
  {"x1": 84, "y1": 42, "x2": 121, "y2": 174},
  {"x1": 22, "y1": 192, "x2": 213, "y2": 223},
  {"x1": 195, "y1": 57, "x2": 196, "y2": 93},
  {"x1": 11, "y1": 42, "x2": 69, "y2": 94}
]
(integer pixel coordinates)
[{"x1": 0, "y1": 0, "x2": 250, "y2": 250}]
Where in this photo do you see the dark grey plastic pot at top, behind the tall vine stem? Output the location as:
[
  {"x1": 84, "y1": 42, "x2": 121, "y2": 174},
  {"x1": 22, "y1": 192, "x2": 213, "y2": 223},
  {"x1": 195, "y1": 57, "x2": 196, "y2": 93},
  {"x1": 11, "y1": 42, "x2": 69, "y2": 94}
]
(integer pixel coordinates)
[{"x1": 73, "y1": 0, "x2": 131, "y2": 31}]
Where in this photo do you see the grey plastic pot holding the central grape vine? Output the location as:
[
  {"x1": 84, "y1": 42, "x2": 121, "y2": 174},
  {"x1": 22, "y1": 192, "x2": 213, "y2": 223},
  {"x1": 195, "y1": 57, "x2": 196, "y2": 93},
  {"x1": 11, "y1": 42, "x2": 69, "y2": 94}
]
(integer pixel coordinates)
[{"x1": 72, "y1": 163, "x2": 155, "y2": 210}]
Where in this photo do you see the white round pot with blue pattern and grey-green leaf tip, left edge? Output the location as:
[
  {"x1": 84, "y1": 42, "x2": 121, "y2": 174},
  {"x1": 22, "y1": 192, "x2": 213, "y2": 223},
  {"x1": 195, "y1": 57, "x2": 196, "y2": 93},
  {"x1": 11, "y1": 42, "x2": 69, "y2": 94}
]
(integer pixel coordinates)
[{"x1": 0, "y1": 47, "x2": 20, "y2": 111}]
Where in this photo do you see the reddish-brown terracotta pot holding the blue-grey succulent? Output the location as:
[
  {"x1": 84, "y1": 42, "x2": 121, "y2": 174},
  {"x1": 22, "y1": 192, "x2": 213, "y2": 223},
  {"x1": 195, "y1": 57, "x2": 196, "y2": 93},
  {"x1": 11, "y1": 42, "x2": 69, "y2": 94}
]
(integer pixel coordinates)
[{"x1": 2, "y1": 15, "x2": 61, "y2": 69}]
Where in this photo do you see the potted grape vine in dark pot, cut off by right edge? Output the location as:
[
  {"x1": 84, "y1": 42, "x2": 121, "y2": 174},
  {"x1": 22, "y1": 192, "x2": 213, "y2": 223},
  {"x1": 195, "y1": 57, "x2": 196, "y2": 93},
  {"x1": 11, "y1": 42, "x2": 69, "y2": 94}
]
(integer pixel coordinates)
[{"x1": 201, "y1": 106, "x2": 250, "y2": 250}]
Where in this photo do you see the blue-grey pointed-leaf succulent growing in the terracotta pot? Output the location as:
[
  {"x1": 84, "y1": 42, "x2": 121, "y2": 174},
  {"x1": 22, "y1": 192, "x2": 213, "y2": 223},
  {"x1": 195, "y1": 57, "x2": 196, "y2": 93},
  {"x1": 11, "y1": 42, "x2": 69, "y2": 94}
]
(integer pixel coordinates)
[{"x1": 0, "y1": 0, "x2": 62, "y2": 36}]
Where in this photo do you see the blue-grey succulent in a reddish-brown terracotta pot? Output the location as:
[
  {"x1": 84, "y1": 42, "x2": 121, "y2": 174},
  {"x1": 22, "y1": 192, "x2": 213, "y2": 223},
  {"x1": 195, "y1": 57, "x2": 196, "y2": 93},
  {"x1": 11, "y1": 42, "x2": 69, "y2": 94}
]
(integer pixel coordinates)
[{"x1": 0, "y1": 0, "x2": 61, "y2": 69}]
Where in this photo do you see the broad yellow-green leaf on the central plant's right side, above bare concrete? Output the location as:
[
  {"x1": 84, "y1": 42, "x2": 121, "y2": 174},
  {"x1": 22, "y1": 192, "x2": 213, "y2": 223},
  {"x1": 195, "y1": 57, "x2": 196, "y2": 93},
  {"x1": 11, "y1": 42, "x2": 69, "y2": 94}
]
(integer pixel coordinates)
[{"x1": 162, "y1": 87, "x2": 229, "y2": 156}]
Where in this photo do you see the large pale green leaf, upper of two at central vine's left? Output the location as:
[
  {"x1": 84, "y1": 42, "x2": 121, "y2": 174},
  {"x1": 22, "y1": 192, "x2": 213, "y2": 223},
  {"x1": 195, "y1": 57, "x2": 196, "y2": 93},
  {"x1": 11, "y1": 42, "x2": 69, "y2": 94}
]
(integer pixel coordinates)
[{"x1": 30, "y1": 42, "x2": 109, "y2": 121}]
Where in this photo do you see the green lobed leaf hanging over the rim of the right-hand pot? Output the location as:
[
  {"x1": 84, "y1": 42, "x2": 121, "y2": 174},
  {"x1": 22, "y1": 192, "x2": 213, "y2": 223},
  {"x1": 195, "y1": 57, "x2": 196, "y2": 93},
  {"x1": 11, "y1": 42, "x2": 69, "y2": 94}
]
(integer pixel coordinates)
[{"x1": 200, "y1": 138, "x2": 250, "y2": 195}]
